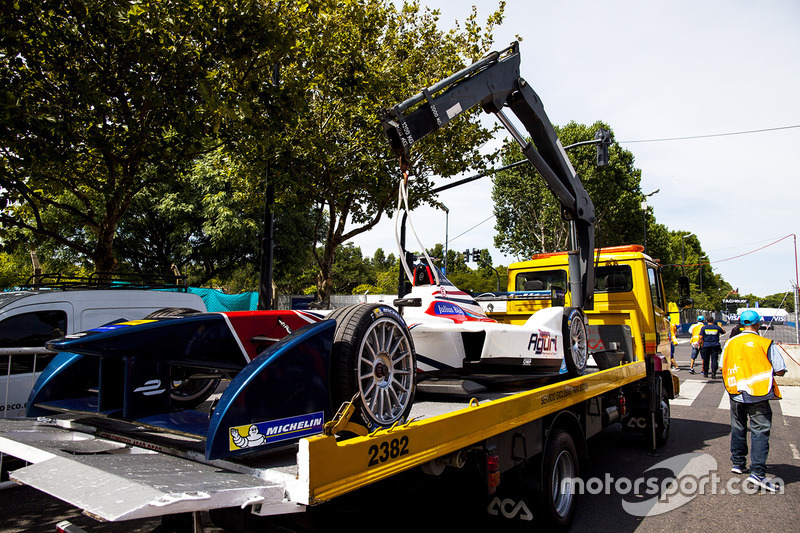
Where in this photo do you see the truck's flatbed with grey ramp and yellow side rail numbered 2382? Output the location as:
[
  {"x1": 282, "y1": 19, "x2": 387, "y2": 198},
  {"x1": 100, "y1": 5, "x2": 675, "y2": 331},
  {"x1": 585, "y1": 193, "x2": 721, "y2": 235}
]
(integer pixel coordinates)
[{"x1": 0, "y1": 361, "x2": 646, "y2": 521}]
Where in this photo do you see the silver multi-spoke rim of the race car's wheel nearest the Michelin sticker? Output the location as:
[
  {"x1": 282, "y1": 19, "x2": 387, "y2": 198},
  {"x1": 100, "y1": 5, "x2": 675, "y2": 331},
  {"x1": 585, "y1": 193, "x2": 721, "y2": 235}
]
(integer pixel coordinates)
[{"x1": 358, "y1": 318, "x2": 414, "y2": 424}]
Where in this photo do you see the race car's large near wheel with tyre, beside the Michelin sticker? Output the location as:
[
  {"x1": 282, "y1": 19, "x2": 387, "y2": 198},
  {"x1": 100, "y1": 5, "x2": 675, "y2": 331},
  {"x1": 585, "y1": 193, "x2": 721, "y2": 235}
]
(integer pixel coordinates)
[{"x1": 328, "y1": 304, "x2": 416, "y2": 430}]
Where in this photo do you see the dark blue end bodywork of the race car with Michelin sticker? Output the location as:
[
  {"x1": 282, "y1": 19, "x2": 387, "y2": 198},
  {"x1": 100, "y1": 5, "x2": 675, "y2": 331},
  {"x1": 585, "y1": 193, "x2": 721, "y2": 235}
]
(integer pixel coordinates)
[{"x1": 28, "y1": 312, "x2": 336, "y2": 460}]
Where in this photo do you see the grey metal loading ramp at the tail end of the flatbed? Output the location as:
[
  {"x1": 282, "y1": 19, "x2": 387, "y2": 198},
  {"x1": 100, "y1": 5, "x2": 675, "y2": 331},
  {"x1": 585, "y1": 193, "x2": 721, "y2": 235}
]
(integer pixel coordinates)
[{"x1": 0, "y1": 420, "x2": 290, "y2": 522}]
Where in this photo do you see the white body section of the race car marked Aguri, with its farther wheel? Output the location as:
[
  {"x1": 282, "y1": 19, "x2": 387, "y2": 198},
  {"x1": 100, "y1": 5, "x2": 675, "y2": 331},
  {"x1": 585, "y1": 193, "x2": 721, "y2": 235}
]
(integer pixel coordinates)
[{"x1": 396, "y1": 263, "x2": 588, "y2": 376}]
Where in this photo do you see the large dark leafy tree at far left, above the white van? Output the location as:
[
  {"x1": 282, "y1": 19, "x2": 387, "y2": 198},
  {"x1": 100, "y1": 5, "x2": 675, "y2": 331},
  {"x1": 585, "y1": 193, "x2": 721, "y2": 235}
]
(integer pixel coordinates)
[{"x1": 0, "y1": 0, "x2": 317, "y2": 278}]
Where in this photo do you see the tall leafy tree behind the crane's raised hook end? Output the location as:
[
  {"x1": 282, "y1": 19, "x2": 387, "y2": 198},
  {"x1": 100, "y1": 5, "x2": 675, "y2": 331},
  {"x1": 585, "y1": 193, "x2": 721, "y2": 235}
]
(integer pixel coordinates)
[{"x1": 282, "y1": 0, "x2": 502, "y2": 301}]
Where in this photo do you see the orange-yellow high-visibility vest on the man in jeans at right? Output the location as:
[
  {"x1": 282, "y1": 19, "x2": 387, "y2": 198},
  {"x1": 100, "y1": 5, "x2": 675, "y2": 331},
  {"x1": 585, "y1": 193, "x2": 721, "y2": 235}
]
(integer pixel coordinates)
[{"x1": 722, "y1": 333, "x2": 781, "y2": 398}]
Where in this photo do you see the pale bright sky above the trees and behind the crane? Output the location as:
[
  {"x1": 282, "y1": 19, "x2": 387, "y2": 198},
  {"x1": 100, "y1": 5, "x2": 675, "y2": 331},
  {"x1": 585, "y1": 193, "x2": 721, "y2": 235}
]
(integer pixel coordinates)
[{"x1": 354, "y1": 0, "x2": 800, "y2": 296}]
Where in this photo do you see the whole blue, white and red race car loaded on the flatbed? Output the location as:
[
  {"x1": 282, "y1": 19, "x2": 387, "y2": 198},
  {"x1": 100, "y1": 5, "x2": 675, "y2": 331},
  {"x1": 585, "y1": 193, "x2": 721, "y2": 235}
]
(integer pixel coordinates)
[{"x1": 28, "y1": 265, "x2": 587, "y2": 459}]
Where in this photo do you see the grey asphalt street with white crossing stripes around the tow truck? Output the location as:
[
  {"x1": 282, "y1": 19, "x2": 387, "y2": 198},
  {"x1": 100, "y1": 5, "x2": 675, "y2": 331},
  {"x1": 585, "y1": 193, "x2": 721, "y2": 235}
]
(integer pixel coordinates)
[{"x1": 0, "y1": 339, "x2": 800, "y2": 533}]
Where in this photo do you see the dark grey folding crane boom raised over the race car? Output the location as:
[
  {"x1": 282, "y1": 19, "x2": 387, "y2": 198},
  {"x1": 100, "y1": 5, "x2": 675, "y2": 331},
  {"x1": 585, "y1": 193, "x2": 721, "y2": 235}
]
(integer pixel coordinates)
[{"x1": 382, "y1": 42, "x2": 596, "y2": 309}]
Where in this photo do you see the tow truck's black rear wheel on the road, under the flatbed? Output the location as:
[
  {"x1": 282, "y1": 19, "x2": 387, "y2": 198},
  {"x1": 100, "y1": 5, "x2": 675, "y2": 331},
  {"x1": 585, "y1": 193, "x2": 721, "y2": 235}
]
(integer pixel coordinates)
[{"x1": 540, "y1": 430, "x2": 579, "y2": 530}]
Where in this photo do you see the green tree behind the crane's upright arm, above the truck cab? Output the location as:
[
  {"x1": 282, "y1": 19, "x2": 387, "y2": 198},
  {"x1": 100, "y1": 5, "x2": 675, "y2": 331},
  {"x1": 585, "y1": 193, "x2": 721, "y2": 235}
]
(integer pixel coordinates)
[{"x1": 492, "y1": 122, "x2": 650, "y2": 258}]
